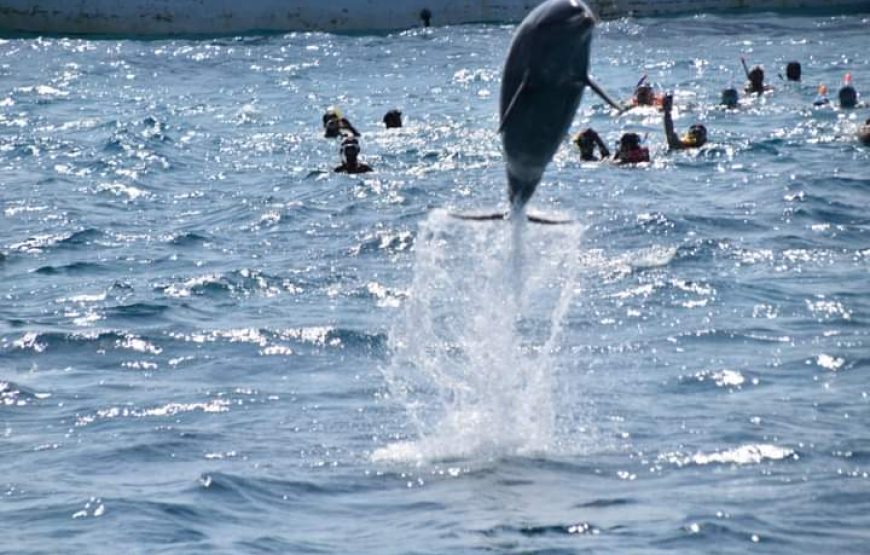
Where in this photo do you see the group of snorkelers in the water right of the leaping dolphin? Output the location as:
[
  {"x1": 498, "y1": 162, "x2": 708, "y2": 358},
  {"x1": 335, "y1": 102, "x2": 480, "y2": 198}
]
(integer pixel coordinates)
[{"x1": 574, "y1": 58, "x2": 870, "y2": 164}]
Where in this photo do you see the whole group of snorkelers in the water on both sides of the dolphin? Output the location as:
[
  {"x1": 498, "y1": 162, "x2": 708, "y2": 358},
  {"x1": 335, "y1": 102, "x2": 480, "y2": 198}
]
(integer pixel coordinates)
[{"x1": 323, "y1": 58, "x2": 870, "y2": 174}]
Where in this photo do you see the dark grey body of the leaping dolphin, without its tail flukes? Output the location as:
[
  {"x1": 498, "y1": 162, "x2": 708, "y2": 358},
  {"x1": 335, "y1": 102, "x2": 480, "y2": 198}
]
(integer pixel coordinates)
[{"x1": 499, "y1": 0, "x2": 622, "y2": 214}]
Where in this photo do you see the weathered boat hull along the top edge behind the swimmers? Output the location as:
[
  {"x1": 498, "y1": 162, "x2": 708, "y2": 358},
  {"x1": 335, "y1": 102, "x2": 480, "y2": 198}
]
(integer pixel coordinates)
[{"x1": 0, "y1": 0, "x2": 870, "y2": 37}]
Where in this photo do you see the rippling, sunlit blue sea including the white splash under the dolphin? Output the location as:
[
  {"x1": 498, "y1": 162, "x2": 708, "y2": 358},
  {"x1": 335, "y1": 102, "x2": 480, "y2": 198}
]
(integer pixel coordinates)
[{"x1": 0, "y1": 9, "x2": 870, "y2": 555}]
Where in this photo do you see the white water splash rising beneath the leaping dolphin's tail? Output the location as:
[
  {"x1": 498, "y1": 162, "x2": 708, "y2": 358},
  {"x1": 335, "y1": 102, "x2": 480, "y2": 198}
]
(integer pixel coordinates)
[{"x1": 373, "y1": 211, "x2": 583, "y2": 461}]
